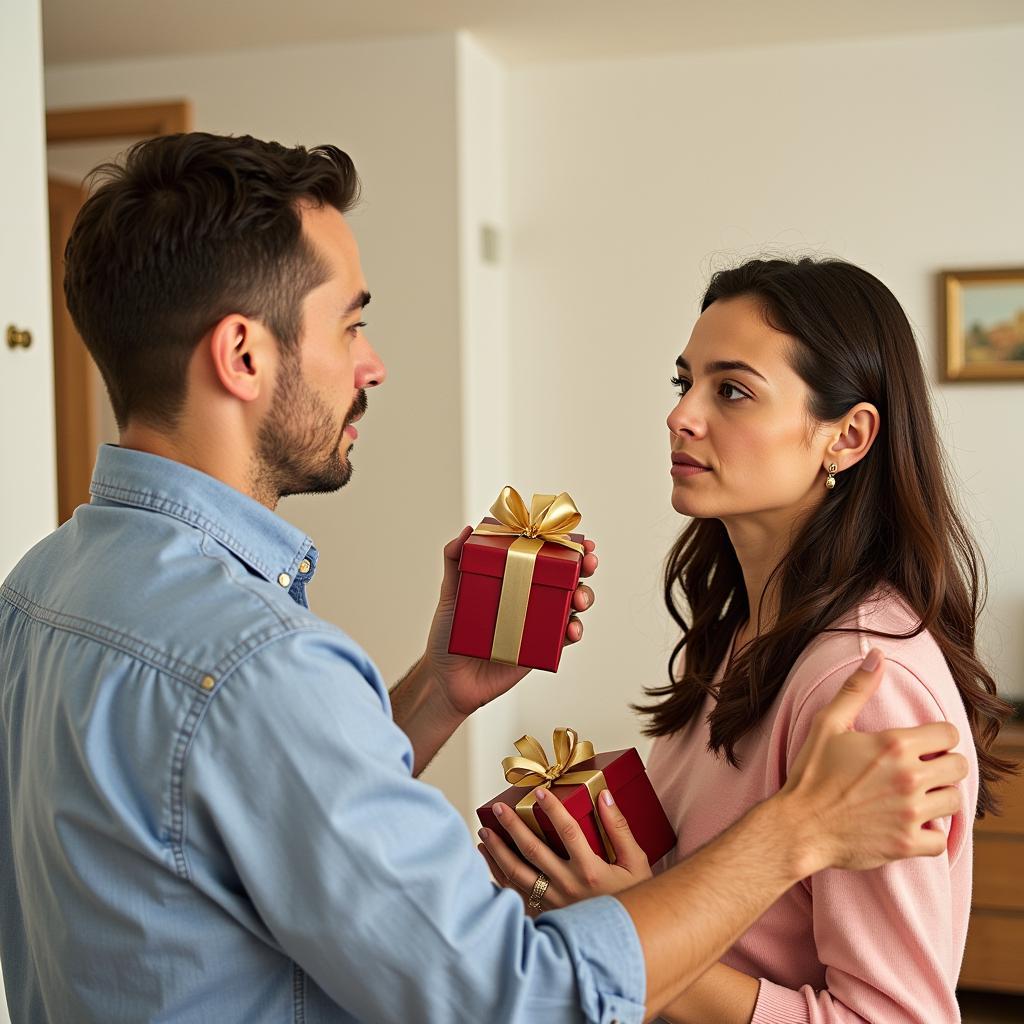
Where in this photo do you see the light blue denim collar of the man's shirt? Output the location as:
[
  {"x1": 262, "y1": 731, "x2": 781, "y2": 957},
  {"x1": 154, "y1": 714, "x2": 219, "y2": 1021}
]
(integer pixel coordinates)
[{"x1": 89, "y1": 444, "x2": 316, "y2": 589}]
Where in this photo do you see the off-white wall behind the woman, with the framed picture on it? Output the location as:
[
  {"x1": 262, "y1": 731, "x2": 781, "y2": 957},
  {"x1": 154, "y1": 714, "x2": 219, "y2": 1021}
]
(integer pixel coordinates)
[{"x1": 508, "y1": 29, "x2": 1024, "y2": 761}]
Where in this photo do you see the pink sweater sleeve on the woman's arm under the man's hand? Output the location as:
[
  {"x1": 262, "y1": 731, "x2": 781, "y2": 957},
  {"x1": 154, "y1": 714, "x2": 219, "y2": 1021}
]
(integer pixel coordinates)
[{"x1": 751, "y1": 660, "x2": 977, "y2": 1024}]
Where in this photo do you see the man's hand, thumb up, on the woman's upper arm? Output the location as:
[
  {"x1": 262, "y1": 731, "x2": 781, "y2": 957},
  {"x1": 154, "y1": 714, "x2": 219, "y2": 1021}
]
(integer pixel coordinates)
[{"x1": 773, "y1": 650, "x2": 968, "y2": 874}]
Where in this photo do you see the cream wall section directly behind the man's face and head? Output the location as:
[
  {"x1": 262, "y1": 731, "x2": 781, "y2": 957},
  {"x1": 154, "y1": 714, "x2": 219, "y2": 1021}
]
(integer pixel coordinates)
[{"x1": 39, "y1": 34, "x2": 469, "y2": 811}]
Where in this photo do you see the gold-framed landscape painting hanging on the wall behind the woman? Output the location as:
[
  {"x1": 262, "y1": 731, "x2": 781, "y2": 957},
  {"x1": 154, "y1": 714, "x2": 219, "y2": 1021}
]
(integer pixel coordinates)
[{"x1": 939, "y1": 267, "x2": 1024, "y2": 381}]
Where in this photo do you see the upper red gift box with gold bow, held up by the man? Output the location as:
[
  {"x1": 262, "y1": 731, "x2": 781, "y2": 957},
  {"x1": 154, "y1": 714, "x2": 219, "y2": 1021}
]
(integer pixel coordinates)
[{"x1": 449, "y1": 487, "x2": 584, "y2": 672}]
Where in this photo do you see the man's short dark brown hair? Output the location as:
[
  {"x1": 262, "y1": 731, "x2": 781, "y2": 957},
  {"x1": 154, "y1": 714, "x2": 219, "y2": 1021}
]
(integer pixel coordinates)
[{"x1": 65, "y1": 132, "x2": 359, "y2": 428}]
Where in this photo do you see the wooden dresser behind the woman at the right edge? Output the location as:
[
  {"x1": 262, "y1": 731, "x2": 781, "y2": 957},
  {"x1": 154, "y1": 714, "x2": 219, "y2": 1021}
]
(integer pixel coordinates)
[{"x1": 959, "y1": 723, "x2": 1024, "y2": 992}]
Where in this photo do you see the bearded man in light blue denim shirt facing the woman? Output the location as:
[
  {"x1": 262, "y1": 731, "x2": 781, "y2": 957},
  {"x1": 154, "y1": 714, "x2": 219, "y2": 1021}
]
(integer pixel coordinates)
[{"x1": 0, "y1": 133, "x2": 966, "y2": 1022}]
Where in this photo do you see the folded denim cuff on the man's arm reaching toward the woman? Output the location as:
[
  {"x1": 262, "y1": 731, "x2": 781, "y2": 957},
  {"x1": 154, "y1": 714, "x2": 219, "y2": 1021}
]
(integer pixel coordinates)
[{"x1": 537, "y1": 896, "x2": 647, "y2": 1024}]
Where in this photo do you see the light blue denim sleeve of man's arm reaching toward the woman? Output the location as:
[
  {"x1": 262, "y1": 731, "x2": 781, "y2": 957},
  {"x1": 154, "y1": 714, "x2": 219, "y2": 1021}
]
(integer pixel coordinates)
[{"x1": 185, "y1": 632, "x2": 645, "y2": 1024}]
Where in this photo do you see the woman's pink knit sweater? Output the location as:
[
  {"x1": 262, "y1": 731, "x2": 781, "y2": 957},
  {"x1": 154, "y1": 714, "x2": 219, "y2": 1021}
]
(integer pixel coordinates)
[{"x1": 648, "y1": 597, "x2": 978, "y2": 1024}]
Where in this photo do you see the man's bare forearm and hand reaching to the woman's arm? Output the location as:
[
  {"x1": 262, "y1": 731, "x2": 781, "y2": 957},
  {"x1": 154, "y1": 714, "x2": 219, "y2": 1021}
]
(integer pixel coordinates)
[{"x1": 615, "y1": 651, "x2": 968, "y2": 1016}]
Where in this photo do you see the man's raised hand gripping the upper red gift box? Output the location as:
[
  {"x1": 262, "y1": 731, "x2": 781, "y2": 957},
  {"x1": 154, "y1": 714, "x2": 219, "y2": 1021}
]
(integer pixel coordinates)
[{"x1": 424, "y1": 526, "x2": 597, "y2": 717}]
